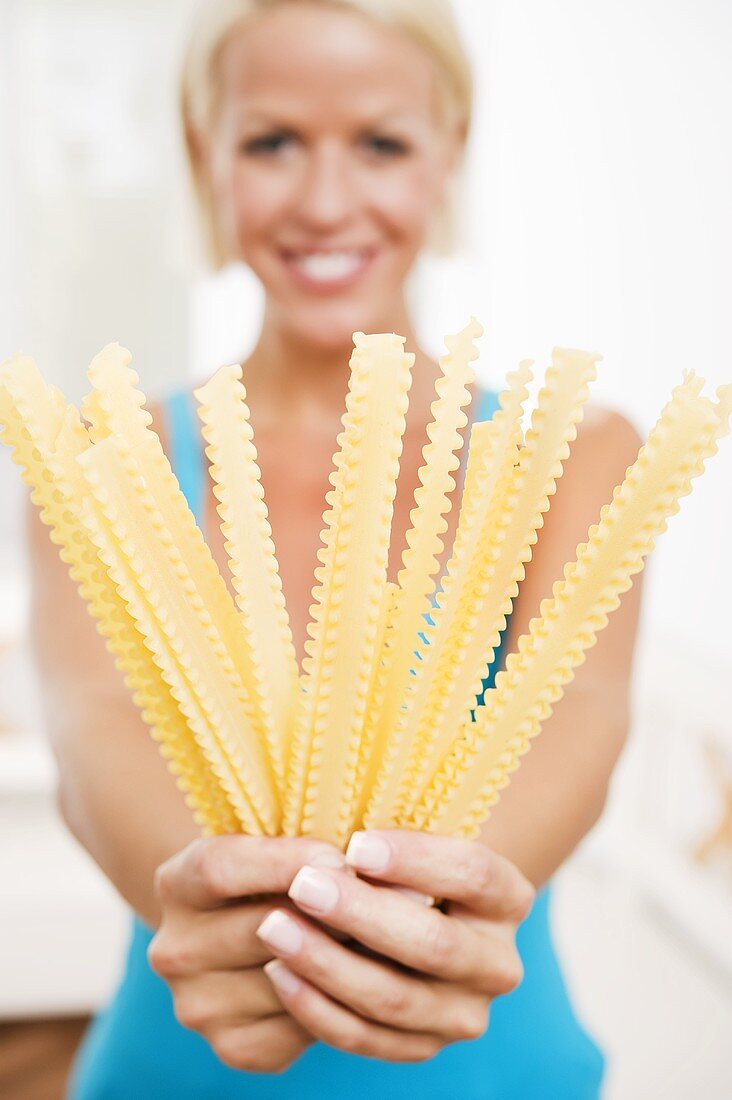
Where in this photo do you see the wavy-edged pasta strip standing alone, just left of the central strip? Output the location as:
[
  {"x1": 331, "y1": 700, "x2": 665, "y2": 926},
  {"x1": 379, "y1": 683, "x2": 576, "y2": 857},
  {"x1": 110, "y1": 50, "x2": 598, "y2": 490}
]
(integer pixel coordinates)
[{"x1": 196, "y1": 366, "x2": 298, "y2": 800}]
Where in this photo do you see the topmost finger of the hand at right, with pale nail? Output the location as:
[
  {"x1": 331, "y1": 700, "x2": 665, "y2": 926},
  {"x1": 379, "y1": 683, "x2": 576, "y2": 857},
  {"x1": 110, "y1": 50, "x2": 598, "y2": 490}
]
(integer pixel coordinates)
[{"x1": 346, "y1": 829, "x2": 536, "y2": 921}]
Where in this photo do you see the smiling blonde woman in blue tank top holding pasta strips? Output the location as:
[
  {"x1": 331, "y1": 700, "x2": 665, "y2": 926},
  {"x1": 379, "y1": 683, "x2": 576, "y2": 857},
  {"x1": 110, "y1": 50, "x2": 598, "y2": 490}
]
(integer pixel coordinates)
[{"x1": 32, "y1": 0, "x2": 638, "y2": 1100}]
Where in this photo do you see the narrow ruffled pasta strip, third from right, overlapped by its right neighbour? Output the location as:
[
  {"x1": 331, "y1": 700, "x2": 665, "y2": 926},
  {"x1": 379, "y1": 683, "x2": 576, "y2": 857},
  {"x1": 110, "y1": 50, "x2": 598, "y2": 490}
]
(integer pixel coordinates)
[{"x1": 363, "y1": 361, "x2": 531, "y2": 828}]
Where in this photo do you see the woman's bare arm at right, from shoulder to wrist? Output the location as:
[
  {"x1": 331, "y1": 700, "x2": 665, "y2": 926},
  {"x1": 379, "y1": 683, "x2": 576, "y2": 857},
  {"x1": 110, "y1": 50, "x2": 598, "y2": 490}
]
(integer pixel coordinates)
[{"x1": 481, "y1": 410, "x2": 641, "y2": 886}]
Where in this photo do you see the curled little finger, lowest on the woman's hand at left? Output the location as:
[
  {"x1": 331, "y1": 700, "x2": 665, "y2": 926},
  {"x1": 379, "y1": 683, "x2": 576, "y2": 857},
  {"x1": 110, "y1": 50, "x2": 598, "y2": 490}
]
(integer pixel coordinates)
[{"x1": 209, "y1": 1013, "x2": 314, "y2": 1069}]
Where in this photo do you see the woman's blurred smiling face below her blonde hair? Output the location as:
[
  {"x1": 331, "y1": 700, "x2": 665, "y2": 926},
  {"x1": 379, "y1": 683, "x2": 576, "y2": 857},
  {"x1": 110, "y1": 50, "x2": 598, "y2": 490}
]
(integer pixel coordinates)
[{"x1": 202, "y1": 3, "x2": 460, "y2": 347}]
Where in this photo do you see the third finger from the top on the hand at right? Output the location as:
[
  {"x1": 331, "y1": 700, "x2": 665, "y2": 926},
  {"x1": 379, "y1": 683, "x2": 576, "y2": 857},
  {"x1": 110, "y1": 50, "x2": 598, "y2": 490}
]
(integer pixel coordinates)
[{"x1": 258, "y1": 910, "x2": 488, "y2": 1042}]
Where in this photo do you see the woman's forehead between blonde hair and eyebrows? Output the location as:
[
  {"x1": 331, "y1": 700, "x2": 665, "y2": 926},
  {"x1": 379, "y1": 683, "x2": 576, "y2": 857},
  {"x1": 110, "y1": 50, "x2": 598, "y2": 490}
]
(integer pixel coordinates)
[{"x1": 212, "y1": 3, "x2": 437, "y2": 120}]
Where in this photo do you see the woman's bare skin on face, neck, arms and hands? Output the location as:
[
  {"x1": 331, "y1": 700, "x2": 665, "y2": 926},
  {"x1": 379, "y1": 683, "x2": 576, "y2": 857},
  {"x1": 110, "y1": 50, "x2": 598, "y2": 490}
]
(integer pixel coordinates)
[{"x1": 30, "y1": 3, "x2": 640, "y2": 1073}]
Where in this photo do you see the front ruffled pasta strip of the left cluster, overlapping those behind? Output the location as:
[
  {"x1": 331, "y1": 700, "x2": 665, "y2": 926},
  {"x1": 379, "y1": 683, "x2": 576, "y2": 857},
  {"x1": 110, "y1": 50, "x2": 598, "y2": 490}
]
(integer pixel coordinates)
[{"x1": 79, "y1": 437, "x2": 278, "y2": 835}]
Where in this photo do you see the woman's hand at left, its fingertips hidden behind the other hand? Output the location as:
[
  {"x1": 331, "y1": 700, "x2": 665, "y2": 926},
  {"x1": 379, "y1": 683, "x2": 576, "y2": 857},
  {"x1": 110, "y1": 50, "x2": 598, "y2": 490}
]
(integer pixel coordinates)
[{"x1": 148, "y1": 836, "x2": 345, "y2": 1073}]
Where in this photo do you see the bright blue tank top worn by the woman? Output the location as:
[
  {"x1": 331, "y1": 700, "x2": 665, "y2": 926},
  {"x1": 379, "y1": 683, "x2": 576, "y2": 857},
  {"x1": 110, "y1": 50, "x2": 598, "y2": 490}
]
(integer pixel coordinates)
[{"x1": 68, "y1": 391, "x2": 604, "y2": 1100}]
